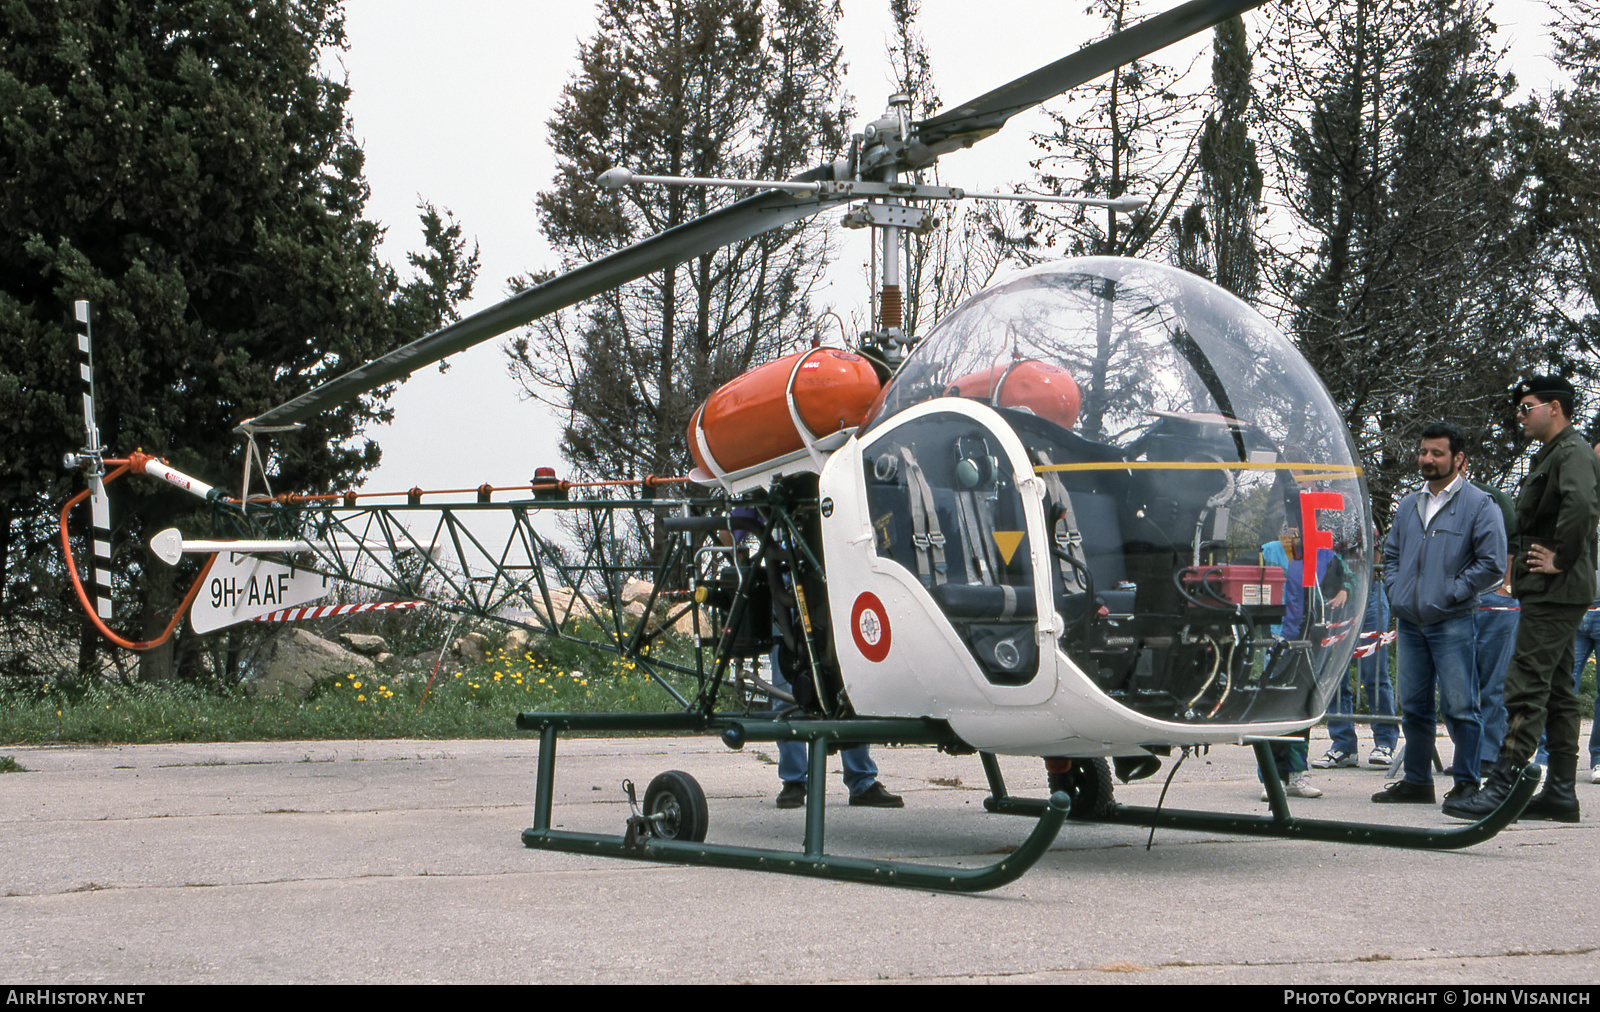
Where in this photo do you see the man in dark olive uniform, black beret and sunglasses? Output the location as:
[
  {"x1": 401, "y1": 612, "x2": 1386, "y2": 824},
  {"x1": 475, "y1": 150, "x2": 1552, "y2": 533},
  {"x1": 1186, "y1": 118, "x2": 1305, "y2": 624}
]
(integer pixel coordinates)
[{"x1": 1445, "y1": 376, "x2": 1600, "y2": 823}]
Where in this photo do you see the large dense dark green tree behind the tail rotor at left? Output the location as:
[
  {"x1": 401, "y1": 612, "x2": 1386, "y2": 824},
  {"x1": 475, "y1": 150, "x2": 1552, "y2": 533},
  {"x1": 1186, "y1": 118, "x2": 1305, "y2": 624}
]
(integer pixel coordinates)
[{"x1": 0, "y1": 0, "x2": 477, "y2": 677}]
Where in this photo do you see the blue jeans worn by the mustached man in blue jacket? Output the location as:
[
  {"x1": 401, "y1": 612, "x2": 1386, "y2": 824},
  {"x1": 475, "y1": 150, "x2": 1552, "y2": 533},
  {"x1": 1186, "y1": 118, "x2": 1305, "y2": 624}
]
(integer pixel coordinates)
[{"x1": 1397, "y1": 612, "x2": 1483, "y2": 785}]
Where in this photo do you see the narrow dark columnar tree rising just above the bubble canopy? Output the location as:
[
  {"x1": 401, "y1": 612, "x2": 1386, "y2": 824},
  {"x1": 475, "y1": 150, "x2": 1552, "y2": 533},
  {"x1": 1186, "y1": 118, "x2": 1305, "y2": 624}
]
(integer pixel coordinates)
[{"x1": 1173, "y1": 18, "x2": 1262, "y2": 301}]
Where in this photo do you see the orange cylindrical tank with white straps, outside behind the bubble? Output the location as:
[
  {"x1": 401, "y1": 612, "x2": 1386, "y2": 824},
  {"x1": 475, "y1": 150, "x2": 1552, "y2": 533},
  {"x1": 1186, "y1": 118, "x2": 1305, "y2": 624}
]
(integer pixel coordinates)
[{"x1": 688, "y1": 347, "x2": 882, "y2": 474}]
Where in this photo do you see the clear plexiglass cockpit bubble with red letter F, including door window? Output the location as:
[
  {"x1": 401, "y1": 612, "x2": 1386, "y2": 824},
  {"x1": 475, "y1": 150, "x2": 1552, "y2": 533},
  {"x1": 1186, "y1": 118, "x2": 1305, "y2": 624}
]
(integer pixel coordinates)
[{"x1": 861, "y1": 258, "x2": 1378, "y2": 724}]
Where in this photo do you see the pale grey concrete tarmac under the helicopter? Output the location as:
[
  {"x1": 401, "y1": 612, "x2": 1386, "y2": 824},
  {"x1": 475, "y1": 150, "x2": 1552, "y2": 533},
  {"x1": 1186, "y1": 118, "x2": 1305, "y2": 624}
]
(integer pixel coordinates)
[{"x1": 0, "y1": 729, "x2": 1600, "y2": 988}]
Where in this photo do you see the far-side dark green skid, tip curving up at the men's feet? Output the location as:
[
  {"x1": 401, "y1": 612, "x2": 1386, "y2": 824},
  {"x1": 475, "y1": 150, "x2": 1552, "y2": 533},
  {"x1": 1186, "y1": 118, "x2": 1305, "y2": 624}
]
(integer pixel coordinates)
[{"x1": 979, "y1": 741, "x2": 1539, "y2": 850}]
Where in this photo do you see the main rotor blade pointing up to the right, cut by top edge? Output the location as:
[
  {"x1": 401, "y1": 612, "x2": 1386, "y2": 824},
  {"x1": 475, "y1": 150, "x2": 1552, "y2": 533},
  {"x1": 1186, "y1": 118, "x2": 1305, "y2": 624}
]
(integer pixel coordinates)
[{"x1": 914, "y1": 0, "x2": 1266, "y2": 155}]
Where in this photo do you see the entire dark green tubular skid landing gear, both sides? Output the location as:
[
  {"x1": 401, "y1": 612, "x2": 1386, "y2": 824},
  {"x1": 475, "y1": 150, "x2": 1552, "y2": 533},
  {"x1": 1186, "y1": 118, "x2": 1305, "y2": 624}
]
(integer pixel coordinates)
[{"x1": 517, "y1": 713, "x2": 1539, "y2": 892}]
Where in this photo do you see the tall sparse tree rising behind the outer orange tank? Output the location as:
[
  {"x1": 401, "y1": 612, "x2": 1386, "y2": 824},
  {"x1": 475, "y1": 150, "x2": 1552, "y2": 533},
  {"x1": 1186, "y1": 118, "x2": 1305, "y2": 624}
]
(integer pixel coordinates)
[{"x1": 506, "y1": 0, "x2": 846, "y2": 554}]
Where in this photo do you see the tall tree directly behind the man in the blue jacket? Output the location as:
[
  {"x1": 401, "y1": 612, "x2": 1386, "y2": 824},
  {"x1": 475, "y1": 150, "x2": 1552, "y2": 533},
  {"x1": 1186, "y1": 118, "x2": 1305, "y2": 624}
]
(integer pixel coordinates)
[{"x1": 1269, "y1": 0, "x2": 1541, "y2": 516}]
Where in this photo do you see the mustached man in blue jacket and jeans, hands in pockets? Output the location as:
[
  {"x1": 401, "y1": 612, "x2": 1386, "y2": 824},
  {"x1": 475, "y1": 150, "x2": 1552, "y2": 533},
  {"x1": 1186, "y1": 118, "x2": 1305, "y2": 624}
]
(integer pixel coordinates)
[{"x1": 1373, "y1": 423, "x2": 1506, "y2": 804}]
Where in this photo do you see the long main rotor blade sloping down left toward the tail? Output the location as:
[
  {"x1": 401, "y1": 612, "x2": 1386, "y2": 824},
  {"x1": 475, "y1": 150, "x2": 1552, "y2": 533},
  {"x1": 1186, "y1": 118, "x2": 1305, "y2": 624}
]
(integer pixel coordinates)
[{"x1": 250, "y1": 167, "x2": 850, "y2": 426}]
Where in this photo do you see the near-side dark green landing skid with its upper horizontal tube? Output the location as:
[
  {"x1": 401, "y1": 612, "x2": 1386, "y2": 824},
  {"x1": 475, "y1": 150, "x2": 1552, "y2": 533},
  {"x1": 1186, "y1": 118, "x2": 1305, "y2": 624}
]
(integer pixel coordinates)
[{"x1": 517, "y1": 711, "x2": 1069, "y2": 892}]
